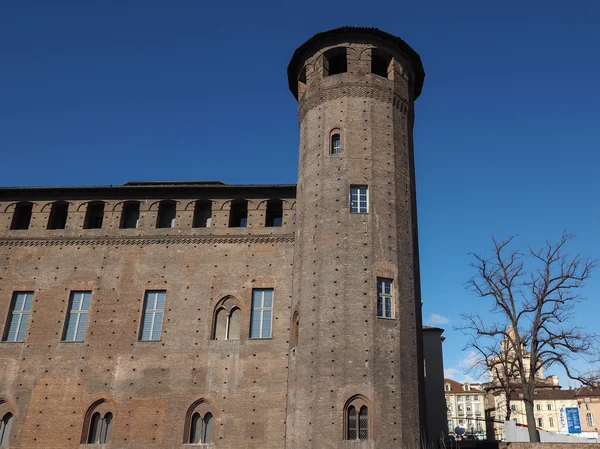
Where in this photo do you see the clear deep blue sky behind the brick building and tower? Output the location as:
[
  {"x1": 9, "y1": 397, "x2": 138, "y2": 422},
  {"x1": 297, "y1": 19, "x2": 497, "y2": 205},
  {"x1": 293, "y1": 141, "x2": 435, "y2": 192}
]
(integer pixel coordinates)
[{"x1": 0, "y1": 0, "x2": 600, "y2": 384}]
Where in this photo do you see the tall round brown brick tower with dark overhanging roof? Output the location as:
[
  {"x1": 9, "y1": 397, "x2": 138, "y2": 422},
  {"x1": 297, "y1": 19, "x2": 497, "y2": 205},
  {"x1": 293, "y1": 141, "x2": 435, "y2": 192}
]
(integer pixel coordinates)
[{"x1": 286, "y1": 27, "x2": 425, "y2": 449}]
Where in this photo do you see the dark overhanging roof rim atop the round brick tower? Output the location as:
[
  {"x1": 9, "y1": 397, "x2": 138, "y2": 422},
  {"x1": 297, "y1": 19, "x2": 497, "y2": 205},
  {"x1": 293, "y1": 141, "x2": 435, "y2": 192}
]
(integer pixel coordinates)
[{"x1": 288, "y1": 26, "x2": 425, "y2": 99}]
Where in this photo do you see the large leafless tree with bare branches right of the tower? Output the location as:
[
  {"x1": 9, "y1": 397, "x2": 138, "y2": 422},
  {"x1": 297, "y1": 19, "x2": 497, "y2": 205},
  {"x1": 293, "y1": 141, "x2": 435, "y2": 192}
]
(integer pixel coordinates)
[{"x1": 461, "y1": 232, "x2": 600, "y2": 442}]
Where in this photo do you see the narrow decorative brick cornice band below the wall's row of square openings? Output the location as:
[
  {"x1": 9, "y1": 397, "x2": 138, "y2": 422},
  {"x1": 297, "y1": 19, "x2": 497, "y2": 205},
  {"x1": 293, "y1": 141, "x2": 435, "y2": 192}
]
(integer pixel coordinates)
[{"x1": 0, "y1": 234, "x2": 294, "y2": 246}]
